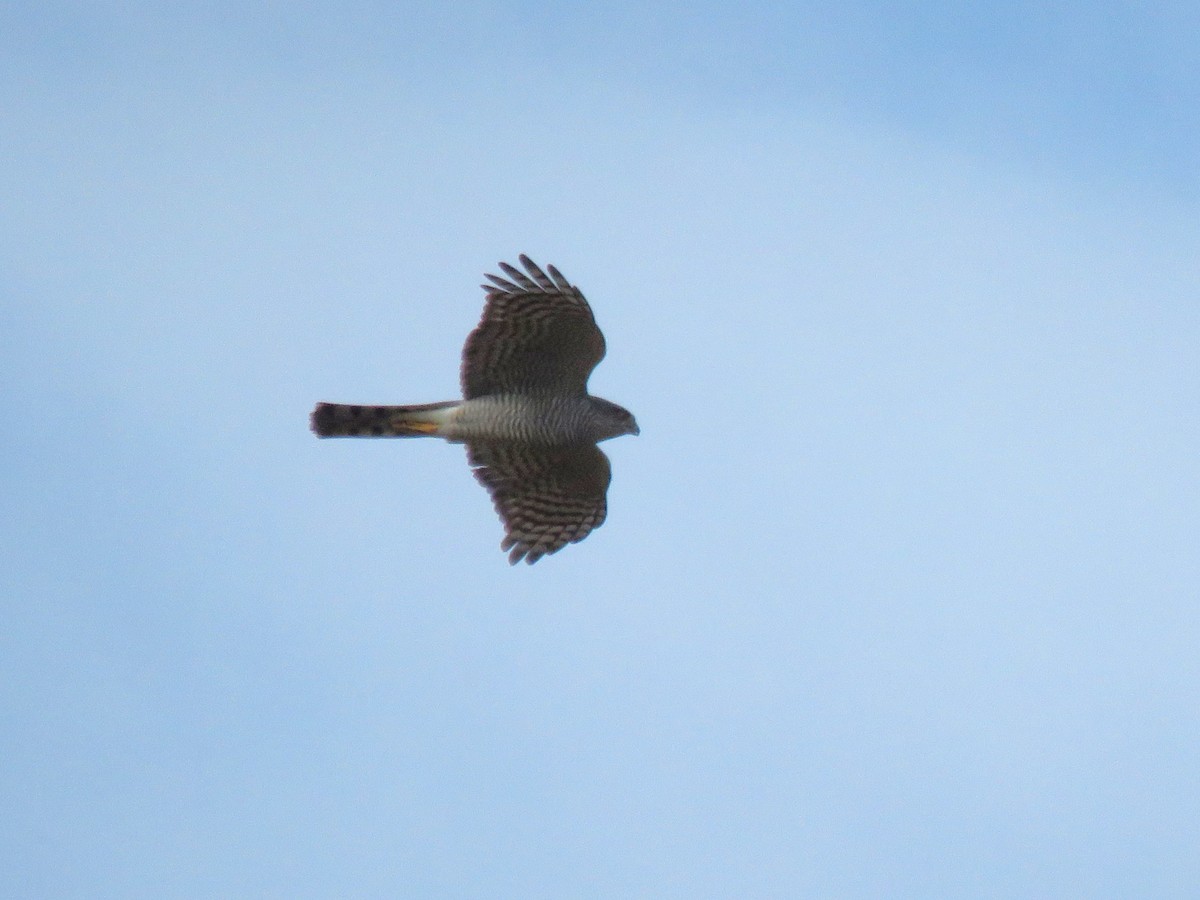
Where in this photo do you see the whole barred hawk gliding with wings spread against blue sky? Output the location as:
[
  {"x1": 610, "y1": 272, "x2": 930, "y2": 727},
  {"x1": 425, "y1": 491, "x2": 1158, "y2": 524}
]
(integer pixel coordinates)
[{"x1": 311, "y1": 256, "x2": 638, "y2": 564}]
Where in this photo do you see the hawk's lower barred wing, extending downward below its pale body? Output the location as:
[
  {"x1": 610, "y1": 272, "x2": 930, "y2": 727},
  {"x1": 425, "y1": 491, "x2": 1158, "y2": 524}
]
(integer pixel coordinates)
[{"x1": 467, "y1": 443, "x2": 612, "y2": 563}]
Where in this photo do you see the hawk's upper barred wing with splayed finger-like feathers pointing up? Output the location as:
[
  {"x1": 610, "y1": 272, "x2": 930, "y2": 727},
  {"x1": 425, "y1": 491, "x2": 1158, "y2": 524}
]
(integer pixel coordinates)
[{"x1": 462, "y1": 260, "x2": 605, "y2": 400}]
